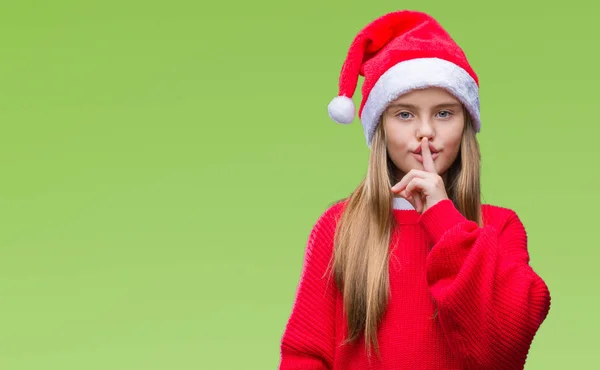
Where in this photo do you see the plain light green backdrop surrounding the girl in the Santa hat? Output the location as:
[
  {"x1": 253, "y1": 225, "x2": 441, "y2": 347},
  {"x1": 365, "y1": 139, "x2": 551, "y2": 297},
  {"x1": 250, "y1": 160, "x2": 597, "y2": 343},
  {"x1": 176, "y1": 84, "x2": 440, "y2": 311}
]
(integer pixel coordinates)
[{"x1": 0, "y1": 0, "x2": 600, "y2": 370}]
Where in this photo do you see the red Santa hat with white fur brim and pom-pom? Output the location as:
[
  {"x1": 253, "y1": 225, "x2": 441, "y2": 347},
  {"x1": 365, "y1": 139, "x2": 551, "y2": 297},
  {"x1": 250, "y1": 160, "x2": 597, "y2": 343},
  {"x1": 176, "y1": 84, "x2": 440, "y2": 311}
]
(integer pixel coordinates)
[{"x1": 328, "y1": 10, "x2": 481, "y2": 147}]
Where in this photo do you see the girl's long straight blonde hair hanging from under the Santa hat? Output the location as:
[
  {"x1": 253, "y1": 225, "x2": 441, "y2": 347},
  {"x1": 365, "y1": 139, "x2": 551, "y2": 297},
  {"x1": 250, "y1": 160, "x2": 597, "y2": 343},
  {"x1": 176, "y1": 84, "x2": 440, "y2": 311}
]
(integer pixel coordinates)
[{"x1": 330, "y1": 110, "x2": 482, "y2": 356}]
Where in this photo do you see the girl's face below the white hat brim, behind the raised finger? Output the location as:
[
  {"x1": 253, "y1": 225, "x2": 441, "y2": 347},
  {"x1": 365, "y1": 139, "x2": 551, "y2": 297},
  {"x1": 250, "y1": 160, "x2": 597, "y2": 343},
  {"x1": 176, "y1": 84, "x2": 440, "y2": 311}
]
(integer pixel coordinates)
[{"x1": 383, "y1": 87, "x2": 465, "y2": 179}]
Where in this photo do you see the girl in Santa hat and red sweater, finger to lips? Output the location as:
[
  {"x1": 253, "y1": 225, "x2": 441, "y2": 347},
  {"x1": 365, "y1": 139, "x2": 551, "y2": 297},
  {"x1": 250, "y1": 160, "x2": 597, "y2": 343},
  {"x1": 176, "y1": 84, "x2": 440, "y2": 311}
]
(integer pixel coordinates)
[{"x1": 279, "y1": 11, "x2": 550, "y2": 370}]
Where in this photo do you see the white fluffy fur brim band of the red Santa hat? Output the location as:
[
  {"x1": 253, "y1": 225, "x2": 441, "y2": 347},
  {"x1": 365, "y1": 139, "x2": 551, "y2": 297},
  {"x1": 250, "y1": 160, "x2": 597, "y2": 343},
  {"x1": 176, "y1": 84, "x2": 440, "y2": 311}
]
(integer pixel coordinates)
[{"x1": 361, "y1": 58, "x2": 481, "y2": 148}]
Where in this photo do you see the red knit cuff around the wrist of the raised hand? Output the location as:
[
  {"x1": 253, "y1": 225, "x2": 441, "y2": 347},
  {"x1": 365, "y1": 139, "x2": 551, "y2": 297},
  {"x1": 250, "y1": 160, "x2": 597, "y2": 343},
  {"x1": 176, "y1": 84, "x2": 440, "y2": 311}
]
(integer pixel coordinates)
[{"x1": 419, "y1": 199, "x2": 469, "y2": 244}]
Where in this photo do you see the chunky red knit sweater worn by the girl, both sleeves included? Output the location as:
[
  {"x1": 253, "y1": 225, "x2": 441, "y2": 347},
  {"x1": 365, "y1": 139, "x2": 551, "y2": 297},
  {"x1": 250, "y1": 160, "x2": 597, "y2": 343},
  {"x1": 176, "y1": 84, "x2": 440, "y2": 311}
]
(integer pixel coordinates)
[{"x1": 279, "y1": 200, "x2": 550, "y2": 370}]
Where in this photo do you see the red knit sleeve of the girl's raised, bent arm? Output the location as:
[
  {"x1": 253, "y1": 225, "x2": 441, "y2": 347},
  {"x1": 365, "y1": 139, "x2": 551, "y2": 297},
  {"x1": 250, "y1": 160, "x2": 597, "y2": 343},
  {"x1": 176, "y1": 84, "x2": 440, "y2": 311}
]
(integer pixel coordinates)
[{"x1": 420, "y1": 200, "x2": 550, "y2": 370}]
